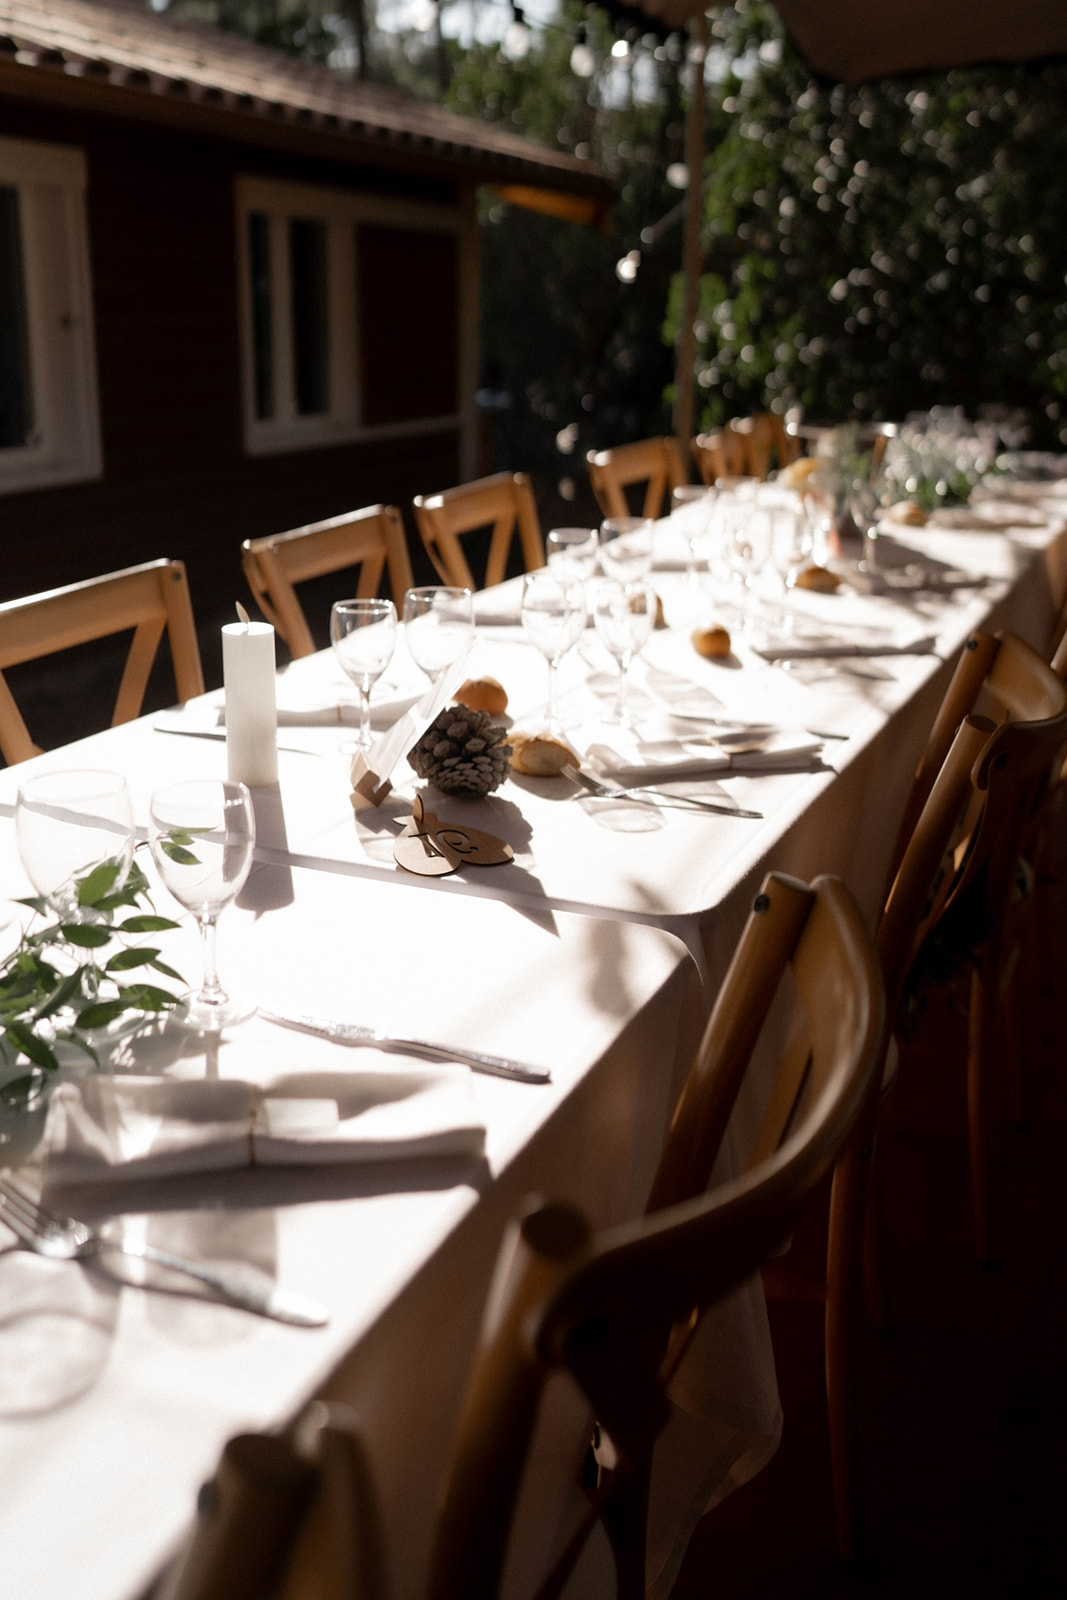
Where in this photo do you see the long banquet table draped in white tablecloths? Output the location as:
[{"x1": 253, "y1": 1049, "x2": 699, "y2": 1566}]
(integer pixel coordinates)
[{"x1": 0, "y1": 483, "x2": 1067, "y2": 1600}]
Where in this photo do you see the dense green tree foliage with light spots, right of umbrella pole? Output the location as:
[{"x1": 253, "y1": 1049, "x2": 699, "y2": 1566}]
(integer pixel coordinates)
[{"x1": 669, "y1": 0, "x2": 1067, "y2": 445}]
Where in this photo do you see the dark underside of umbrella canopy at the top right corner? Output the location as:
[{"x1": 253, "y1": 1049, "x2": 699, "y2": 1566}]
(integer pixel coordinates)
[{"x1": 620, "y1": 0, "x2": 1067, "y2": 83}]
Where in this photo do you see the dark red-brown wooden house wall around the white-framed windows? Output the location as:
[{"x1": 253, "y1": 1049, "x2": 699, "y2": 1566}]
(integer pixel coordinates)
[{"x1": 0, "y1": 101, "x2": 477, "y2": 633}]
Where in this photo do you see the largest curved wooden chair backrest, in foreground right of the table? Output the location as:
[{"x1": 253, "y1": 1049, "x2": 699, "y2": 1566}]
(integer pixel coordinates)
[{"x1": 429, "y1": 874, "x2": 883, "y2": 1600}]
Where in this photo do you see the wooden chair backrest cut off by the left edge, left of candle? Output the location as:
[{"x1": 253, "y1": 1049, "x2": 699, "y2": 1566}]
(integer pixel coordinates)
[{"x1": 0, "y1": 560, "x2": 203, "y2": 763}]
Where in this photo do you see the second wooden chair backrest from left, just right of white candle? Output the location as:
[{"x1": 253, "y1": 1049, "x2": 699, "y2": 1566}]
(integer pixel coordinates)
[{"x1": 242, "y1": 506, "x2": 411, "y2": 658}]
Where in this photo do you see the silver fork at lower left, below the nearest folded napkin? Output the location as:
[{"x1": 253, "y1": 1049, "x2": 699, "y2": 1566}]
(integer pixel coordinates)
[{"x1": 0, "y1": 1176, "x2": 330, "y2": 1328}]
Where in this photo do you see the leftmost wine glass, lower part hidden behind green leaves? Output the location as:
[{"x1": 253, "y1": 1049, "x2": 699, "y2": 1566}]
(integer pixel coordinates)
[{"x1": 14, "y1": 768, "x2": 133, "y2": 922}]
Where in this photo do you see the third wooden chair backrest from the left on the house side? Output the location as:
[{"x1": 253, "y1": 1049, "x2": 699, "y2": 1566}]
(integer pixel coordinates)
[{"x1": 414, "y1": 472, "x2": 544, "y2": 589}]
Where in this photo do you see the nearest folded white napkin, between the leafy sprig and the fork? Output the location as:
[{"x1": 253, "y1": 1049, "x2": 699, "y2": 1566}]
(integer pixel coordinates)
[{"x1": 45, "y1": 1061, "x2": 485, "y2": 1184}]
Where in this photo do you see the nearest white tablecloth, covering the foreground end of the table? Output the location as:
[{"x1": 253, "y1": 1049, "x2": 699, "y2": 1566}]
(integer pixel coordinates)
[{"x1": 0, "y1": 864, "x2": 694, "y2": 1600}]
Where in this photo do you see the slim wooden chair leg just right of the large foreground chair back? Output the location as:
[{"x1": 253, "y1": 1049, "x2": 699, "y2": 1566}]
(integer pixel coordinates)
[{"x1": 825, "y1": 1146, "x2": 865, "y2": 1560}]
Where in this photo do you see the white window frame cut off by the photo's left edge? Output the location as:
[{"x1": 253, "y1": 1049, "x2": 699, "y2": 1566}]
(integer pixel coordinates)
[{"x1": 0, "y1": 139, "x2": 102, "y2": 494}]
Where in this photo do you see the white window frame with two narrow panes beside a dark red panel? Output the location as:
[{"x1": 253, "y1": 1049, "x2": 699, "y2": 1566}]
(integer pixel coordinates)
[{"x1": 235, "y1": 178, "x2": 464, "y2": 456}]
